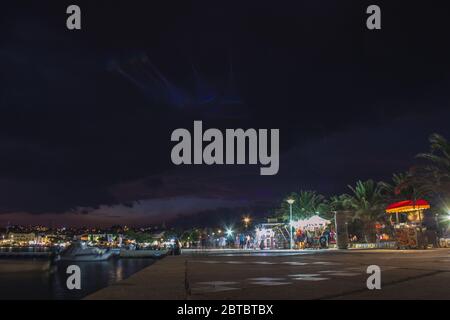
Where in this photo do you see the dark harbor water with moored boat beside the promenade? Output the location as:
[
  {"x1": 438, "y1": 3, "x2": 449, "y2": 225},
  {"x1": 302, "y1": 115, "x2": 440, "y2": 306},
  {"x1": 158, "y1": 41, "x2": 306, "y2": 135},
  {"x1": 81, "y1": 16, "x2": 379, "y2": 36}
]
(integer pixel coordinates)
[{"x1": 0, "y1": 242, "x2": 169, "y2": 300}]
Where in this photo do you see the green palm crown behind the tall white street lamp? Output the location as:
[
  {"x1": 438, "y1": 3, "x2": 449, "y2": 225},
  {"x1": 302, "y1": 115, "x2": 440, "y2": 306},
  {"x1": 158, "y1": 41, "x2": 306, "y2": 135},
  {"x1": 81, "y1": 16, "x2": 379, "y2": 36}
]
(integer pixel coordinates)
[{"x1": 278, "y1": 190, "x2": 328, "y2": 220}]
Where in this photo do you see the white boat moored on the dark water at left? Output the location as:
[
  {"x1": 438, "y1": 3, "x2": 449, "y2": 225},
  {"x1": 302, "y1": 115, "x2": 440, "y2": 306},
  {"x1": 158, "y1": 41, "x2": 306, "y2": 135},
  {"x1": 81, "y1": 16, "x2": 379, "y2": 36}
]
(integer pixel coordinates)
[{"x1": 58, "y1": 242, "x2": 114, "y2": 262}]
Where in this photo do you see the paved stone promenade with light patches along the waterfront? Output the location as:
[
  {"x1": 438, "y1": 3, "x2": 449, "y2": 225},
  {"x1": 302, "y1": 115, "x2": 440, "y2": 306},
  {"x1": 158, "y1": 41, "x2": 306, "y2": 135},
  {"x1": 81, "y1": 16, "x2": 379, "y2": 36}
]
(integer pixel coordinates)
[{"x1": 87, "y1": 249, "x2": 450, "y2": 300}]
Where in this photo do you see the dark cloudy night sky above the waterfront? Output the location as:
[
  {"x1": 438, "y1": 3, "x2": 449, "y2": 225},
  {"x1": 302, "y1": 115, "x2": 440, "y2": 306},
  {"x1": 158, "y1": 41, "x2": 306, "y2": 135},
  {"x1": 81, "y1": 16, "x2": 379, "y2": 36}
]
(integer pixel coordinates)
[{"x1": 0, "y1": 0, "x2": 450, "y2": 225}]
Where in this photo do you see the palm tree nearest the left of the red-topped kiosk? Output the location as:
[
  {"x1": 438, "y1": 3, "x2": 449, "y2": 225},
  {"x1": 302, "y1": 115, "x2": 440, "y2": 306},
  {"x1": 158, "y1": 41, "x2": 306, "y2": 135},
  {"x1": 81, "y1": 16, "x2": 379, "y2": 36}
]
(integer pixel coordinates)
[{"x1": 346, "y1": 180, "x2": 384, "y2": 242}]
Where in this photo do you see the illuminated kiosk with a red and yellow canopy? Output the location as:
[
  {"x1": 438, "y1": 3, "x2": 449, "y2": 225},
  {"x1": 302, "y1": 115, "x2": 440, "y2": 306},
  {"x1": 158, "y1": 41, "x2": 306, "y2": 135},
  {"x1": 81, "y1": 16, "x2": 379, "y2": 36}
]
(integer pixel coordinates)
[{"x1": 386, "y1": 199, "x2": 430, "y2": 249}]
